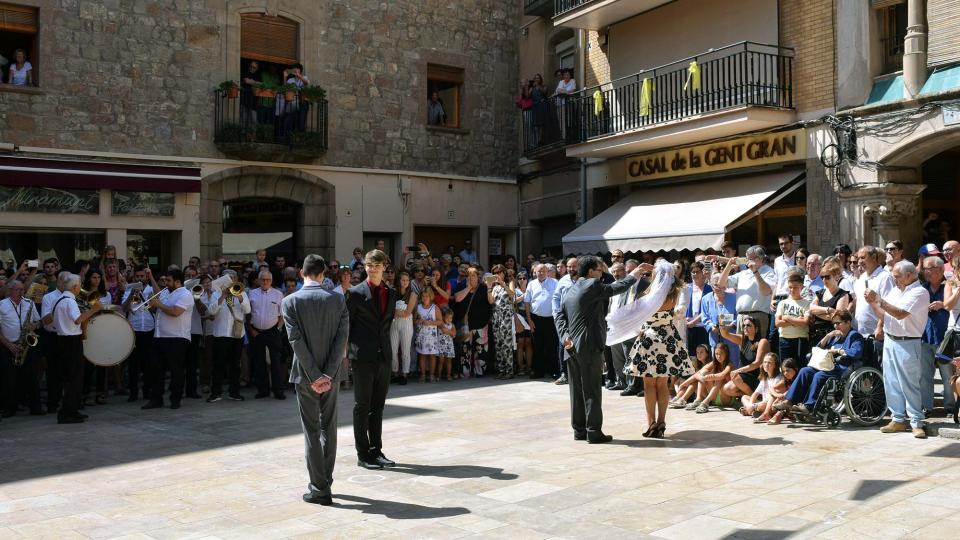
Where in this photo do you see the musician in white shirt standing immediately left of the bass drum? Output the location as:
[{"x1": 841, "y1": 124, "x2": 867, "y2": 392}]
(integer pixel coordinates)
[{"x1": 52, "y1": 274, "x2": 103, "y2": 424}]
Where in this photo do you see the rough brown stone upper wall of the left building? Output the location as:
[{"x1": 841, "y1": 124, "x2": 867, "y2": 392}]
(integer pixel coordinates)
[{"x1": 0, "y1": 0, "x2": 519, "y2": 177}]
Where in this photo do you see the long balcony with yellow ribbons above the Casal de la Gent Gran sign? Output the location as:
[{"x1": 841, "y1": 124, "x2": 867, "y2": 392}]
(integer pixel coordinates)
[{"x1": 523, "y1": 42, "x2": 795, "y2": 159}]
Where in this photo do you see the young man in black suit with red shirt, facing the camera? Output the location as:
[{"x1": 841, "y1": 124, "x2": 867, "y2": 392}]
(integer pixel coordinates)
[{"x1": 346, "y1": 249, "x2": 397, "y2": 469}]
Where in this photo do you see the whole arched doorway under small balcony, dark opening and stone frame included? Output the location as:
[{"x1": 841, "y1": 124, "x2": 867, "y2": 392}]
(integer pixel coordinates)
[{"x1": 200, "y1": 167, "x2": 336, "y2": 261}]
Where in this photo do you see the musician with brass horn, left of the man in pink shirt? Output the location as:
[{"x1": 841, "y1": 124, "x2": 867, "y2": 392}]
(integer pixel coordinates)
[{"x1": 207, "y1": 270, "x2": 250, "y2": 403}]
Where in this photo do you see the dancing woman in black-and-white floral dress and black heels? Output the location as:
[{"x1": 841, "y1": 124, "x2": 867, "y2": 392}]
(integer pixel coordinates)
[{"x1": 626, "y1": 264, "x2": 694, "y2": 439}]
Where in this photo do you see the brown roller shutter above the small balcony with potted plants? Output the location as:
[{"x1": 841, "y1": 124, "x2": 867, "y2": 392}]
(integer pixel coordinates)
[{"x1": 240, "y1": 13, "x2": 300, "y2": 65}]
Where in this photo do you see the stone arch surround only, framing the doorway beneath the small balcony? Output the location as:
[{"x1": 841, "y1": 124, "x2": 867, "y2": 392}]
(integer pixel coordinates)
[{"x1": 200, "y1": 166, "x2": 337, "y2": 259}]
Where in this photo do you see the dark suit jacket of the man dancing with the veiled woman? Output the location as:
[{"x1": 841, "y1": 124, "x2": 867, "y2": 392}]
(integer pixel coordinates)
[{"x1": 556, "y1": 275, "x2": 637, "y2": 353}]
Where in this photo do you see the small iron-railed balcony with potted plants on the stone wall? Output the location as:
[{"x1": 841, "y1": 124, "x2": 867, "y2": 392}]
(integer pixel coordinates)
[{"x1": 213, "y1": 89, "x2": 328, "y2": 162}]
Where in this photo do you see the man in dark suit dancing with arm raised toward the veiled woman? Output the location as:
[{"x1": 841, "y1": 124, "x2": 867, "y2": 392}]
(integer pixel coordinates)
[{"x1": 556, "y1": 255, "x2": 650, "y2": 444}]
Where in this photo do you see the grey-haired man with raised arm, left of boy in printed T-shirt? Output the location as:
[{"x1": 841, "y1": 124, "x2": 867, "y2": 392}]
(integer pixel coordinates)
[{"x1": 710, "y1": 246, "x2": 777, "y2": 337}]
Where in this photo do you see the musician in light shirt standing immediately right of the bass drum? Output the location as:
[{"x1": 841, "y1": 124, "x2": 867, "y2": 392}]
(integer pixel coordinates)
[{"x1": 123, "y1": 265, "x2": 157, "y2": 403}]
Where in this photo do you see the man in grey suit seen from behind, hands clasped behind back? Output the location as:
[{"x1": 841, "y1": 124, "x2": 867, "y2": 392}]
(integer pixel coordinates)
[{"x1": 281, "y1": 255, "x2": 350, "y2": 506}]
